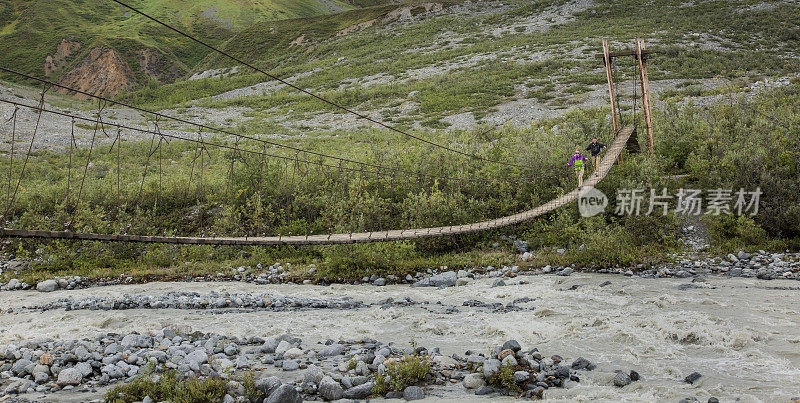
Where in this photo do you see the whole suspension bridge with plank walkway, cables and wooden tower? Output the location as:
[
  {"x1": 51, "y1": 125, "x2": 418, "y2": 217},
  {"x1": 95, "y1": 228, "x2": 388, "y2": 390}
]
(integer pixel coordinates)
[{"x1": 0, "y1": 0, "x2": 652, "y2": 245}]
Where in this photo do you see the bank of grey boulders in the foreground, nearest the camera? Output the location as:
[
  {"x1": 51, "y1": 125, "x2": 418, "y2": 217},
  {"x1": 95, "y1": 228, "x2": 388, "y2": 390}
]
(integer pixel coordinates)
[{"x1": 0, "y1": 328, "x2": 596, "y2": 403}]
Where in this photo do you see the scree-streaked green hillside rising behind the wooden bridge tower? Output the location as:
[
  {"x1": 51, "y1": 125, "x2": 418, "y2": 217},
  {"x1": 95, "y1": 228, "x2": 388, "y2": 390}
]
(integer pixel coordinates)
[{"x1": 117, "y1": 0, "x2": 800, "y2": 128}]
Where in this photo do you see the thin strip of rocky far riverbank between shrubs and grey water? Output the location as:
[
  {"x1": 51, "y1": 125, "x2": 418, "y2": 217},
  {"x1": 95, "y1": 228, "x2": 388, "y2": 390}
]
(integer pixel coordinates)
[{"x1": 0, "y1": 246, "x2": 800, "y2": 292}]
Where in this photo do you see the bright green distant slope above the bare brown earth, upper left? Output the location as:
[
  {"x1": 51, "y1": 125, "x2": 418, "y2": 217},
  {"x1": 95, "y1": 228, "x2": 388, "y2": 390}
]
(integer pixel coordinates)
[{"x1": 0, "y1": 0, "x2": 352, "y2": 87}]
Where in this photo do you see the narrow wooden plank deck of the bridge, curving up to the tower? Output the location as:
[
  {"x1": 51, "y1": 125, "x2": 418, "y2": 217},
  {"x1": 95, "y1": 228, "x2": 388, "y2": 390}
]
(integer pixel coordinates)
[{"x1": 0, "y1": 127, "x2": 634, "y2": 245}]
